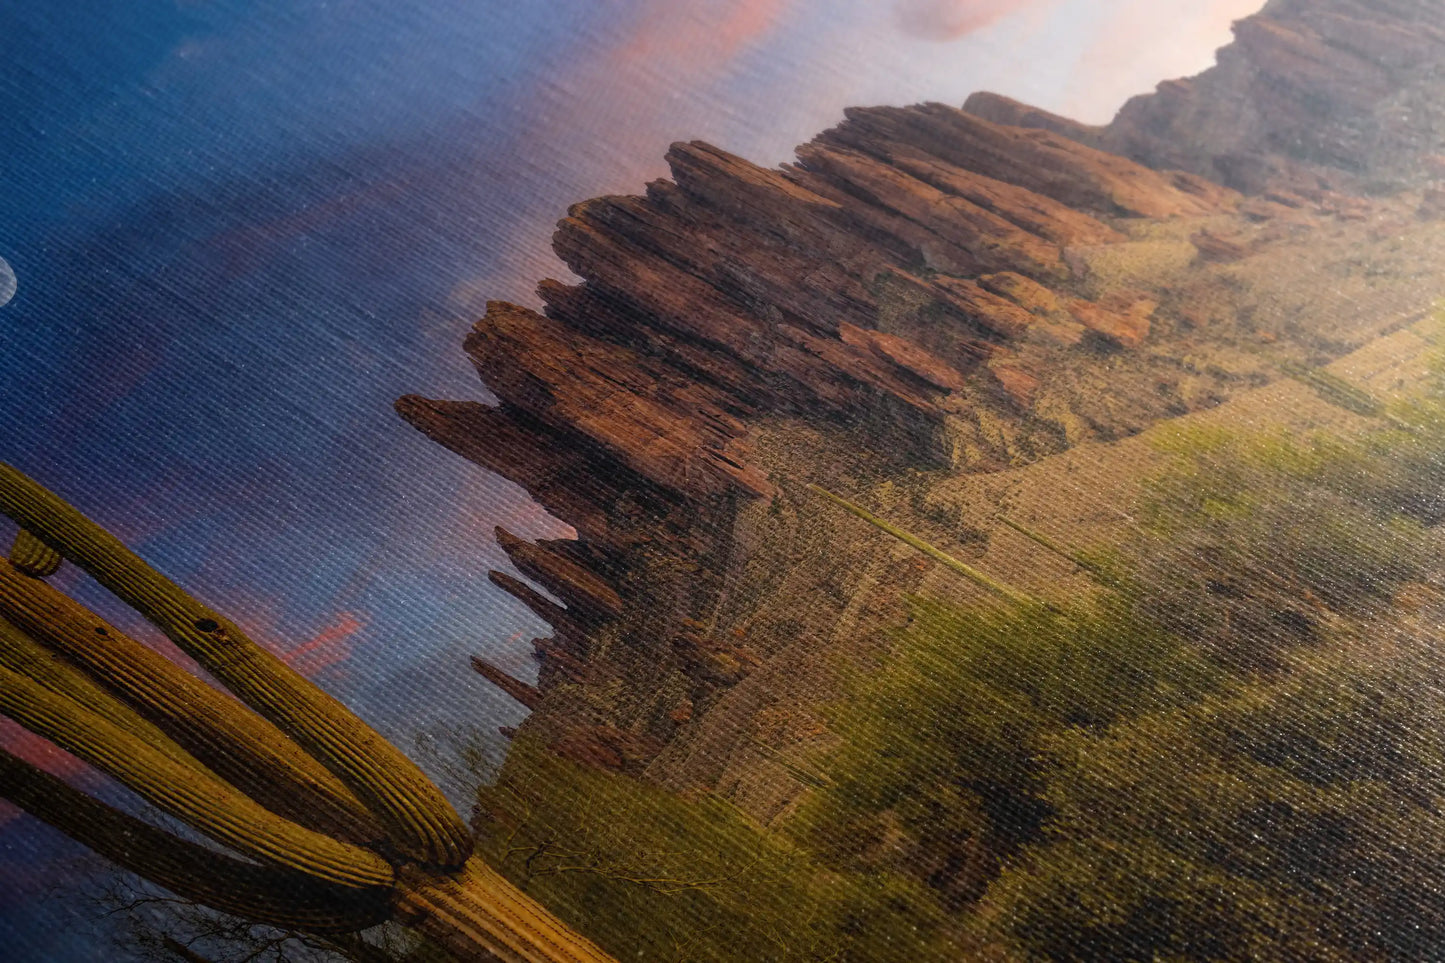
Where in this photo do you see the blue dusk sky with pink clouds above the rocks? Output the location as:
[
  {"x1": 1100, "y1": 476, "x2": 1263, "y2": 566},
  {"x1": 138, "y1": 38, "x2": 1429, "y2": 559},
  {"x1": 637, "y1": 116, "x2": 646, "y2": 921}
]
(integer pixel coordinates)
[{"x1": 0, "y1": 0, "x2": 1257, "y2": 960}]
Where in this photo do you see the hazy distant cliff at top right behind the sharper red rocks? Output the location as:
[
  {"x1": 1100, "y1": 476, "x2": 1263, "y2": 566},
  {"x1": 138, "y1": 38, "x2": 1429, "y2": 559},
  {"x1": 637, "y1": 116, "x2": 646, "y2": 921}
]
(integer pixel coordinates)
[{"x1": 968, "y1": 0, "x2": 1445, "y2": 192}]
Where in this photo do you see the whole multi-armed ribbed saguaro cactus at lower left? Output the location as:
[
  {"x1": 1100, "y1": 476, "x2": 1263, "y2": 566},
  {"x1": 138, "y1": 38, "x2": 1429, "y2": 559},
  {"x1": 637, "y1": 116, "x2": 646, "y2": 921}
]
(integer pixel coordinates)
[{"x1": 0, "y1": 464, "x2": 610, "y2": 963}]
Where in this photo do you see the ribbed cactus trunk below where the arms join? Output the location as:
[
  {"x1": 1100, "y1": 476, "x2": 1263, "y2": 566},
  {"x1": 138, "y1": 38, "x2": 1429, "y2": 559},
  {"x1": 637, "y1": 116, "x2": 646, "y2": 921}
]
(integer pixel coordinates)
[{"x1": 393, "y1": 857, "x2": 616, "y2": 963}]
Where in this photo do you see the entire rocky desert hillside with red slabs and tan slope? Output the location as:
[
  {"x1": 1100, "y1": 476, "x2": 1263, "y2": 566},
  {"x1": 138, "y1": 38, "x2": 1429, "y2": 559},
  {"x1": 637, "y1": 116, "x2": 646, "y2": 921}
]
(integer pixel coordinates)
[{"x1": 397, "y1": 0, "x2": 1445, "y2": 959}]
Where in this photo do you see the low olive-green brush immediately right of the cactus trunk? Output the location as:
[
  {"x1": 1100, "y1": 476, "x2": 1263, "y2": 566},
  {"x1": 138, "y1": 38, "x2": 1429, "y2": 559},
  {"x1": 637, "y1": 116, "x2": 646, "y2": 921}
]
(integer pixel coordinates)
[{"x1": 477, "y1": 740, "x2": 942, "y2": 963}]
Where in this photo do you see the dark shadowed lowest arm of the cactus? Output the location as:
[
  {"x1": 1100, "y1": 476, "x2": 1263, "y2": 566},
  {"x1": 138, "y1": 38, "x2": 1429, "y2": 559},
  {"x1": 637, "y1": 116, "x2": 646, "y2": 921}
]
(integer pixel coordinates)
[{"x1": 0, "y1": 750, "x2": 390, "y2": 933}]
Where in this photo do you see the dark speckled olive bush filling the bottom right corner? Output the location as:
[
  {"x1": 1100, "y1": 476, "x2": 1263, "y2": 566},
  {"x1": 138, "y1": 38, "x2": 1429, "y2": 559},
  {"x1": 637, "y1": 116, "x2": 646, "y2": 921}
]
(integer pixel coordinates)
[{"x1": 978, "y1": 654, "x2": 1445, "y2": 962}]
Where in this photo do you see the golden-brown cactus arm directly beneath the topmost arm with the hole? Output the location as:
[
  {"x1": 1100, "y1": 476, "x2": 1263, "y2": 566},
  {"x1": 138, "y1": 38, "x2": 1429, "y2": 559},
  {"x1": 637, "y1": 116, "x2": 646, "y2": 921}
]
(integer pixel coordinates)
[{"x1": 0, "y1": 561, "x2": 383, "y2": 844}]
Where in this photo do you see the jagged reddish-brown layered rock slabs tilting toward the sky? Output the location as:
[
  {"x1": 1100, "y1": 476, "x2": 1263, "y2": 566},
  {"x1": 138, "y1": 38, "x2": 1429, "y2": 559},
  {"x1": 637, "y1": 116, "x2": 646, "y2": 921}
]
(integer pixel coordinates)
[{"x1": 397, "y1": 104, "x2": 1235, "y2": 563}]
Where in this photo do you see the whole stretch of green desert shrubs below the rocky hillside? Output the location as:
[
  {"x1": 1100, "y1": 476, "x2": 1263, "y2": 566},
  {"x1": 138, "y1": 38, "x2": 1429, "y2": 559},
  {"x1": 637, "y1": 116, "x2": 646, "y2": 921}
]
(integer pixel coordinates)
[{"x1": 465, "y1": 348, "x2": 1445, "y2": 963}]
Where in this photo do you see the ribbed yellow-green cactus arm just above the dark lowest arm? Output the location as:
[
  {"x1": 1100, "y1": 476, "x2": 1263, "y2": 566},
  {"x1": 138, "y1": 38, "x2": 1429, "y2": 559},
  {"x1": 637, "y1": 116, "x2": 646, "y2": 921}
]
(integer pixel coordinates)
[{"x1": 0, "y1": 667, "x2": 393, "y2": 889}]
